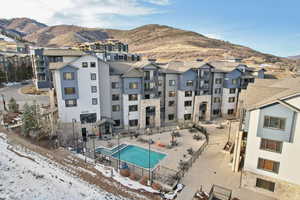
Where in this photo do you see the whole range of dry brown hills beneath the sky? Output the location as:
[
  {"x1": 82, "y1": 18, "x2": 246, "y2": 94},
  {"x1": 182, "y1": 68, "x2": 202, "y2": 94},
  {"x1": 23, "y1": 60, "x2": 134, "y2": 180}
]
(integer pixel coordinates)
[{"x1": 0, "y1": 18, "x2": 295, "y2": 66}]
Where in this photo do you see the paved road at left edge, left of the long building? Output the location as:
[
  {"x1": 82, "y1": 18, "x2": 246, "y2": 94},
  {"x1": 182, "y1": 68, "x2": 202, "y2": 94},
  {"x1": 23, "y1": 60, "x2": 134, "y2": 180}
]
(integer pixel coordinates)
[{"x1": 0, "y1": 85, "x2": 49, "y2": 110}]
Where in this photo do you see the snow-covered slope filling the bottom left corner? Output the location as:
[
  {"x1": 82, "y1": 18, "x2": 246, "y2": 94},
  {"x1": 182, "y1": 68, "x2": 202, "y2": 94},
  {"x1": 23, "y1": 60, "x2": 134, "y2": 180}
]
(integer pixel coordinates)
[{"x1": 0, "y1": 133, "x2": 123, "y2": 200}]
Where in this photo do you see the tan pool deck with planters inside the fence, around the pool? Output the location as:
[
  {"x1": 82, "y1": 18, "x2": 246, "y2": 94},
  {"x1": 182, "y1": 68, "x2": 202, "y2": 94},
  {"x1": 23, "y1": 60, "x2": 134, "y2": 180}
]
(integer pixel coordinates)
[{"x1": 87, "y1": 129, "x2": 205, "y2": 170}]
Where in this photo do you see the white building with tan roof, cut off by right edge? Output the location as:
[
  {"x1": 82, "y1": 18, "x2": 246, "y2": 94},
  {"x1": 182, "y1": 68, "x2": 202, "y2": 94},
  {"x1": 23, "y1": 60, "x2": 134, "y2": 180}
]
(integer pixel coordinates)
[{"x1": 238, "y1": 78, "x2": 300, "y2": 200}]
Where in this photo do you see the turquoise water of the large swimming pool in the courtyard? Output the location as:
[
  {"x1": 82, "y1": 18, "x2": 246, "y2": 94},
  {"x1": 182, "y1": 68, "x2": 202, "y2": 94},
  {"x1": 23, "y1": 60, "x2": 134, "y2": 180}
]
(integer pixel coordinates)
[{"x1": 112, "y1": 145, "x2": 166, "y2": 168}]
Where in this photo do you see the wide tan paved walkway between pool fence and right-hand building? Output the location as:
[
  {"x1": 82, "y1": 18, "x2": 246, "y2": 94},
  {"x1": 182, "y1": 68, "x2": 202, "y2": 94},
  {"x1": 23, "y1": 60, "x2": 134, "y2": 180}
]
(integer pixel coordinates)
[{"x1": 178, "y1": 122, "x2": 273, "y2": 200}]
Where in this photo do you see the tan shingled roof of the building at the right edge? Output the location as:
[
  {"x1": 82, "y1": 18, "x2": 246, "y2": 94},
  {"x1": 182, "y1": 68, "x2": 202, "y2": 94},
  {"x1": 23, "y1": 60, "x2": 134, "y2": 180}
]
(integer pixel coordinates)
[{"x1": 241, "y1": 78, "x2": 300, "y2": 110}]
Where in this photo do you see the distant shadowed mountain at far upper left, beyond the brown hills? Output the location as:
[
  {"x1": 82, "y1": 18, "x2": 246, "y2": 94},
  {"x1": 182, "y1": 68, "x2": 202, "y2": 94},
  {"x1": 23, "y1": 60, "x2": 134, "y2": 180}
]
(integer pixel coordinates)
[{"x1": 0, "y1": 18, "x2": 47, "y2": 36}]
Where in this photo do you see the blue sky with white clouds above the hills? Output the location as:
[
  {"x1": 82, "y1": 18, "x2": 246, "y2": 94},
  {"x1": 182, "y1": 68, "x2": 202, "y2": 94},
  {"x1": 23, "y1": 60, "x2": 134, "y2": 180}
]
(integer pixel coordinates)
[{"x1": 0, "y1": 0, "x2": 300, "y2": 56}]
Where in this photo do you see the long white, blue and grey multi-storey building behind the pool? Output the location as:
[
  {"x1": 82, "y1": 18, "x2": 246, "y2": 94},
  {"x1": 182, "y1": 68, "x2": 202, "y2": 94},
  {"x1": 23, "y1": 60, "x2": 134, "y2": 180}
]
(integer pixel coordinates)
[{"x1": 50, "y1": 51, "x2": 264, "y2": 138}]
